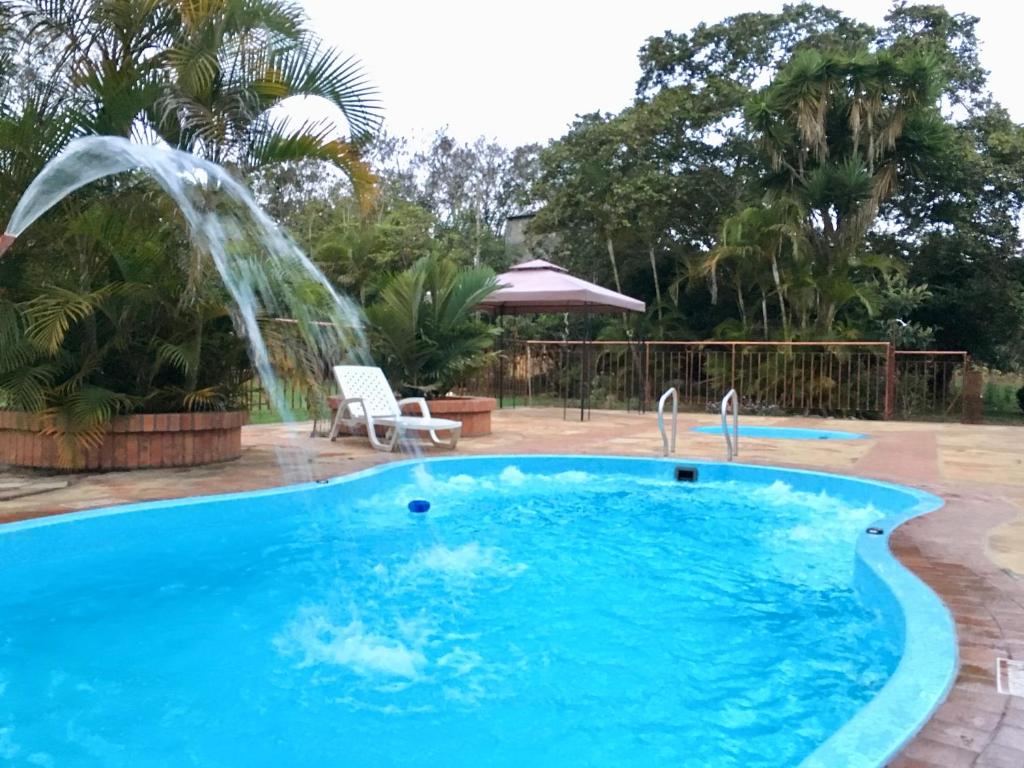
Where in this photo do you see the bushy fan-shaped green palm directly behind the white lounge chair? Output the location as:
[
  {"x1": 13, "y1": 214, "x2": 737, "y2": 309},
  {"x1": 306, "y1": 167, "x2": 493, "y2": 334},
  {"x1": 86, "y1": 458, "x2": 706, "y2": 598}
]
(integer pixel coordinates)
[{"x1": 367, "y1": 256, "x2": 499, "y2": 397}]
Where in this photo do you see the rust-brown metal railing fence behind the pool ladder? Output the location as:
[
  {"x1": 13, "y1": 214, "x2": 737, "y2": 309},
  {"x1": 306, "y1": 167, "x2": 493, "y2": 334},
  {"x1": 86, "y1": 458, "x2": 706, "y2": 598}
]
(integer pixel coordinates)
[{"x1": 460, "y1": 341, "x2": 969, "y2": 419}]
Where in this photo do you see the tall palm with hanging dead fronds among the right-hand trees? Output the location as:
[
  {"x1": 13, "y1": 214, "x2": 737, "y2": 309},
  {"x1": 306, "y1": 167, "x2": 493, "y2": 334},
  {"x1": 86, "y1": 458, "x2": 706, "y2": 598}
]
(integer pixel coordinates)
[{"x1": 746, "y1": 50, "x2": 943, "y2": 333}]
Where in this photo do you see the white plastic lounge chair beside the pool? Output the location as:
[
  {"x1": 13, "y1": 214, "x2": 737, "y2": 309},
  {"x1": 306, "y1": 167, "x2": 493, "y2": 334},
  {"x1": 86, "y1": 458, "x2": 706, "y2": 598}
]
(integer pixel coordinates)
[{"x1": 331, "y1": 366, "x2": 462, "y2": 452}]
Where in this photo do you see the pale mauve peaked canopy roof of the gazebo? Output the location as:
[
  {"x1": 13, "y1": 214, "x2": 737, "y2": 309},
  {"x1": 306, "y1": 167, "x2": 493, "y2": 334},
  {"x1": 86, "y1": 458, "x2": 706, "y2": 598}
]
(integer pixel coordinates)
[{"x1": 478, "y1": 259, "x2": 645, "y2": 314}]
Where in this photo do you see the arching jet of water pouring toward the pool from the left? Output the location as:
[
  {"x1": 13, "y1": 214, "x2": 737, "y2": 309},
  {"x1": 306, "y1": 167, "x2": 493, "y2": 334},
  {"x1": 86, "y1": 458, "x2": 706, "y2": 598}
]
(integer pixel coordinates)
[{"x1": 0, "y1": 136, "x2": 369, "y2": 479}]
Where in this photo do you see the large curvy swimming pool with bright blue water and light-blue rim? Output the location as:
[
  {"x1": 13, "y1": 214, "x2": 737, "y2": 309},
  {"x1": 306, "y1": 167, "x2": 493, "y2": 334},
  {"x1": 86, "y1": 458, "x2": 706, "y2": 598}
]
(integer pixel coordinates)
[{"x1": 0, "y1": 457, "x2": 955, "y2": 768}]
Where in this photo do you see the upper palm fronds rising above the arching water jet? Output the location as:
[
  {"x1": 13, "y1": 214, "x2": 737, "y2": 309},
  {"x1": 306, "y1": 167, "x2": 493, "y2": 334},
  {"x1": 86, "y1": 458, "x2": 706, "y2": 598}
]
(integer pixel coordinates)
[{"x1": 16, "y1": 0, "x2": 380, "y2": 190}]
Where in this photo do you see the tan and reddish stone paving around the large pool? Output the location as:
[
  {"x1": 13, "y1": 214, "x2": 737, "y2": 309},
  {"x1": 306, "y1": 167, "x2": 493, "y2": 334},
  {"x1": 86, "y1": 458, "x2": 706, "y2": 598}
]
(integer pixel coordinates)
[{"x1": 0, "y1": 409, "x2": 1024, "y2": 768}]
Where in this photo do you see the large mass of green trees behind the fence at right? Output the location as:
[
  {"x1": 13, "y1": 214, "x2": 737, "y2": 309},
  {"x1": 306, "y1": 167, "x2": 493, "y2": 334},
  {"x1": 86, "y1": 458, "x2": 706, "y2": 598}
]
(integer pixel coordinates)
[{"x1": 534, "y1": 3, "x2": 1024, "y2": 367}]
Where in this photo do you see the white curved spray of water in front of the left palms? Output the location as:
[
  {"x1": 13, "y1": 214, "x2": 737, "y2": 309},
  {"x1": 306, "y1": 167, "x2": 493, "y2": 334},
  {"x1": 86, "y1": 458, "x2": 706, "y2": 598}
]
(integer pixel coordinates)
[{"x1": 0, "y1": 136, "x2": 369, "y2": 475}]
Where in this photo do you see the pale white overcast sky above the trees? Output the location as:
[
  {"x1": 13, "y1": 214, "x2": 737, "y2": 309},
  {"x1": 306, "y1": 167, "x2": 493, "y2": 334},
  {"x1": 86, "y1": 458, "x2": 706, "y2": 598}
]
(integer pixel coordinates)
[{"x1": 303, "y1": 0, "x2": 1024, "y2": 146}]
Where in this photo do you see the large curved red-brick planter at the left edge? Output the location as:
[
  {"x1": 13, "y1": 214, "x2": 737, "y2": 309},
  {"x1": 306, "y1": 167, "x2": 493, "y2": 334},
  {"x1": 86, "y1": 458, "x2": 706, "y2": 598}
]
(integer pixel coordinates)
[{"x1": 0, "y1": 411, "x2": 249, "y2": 470}]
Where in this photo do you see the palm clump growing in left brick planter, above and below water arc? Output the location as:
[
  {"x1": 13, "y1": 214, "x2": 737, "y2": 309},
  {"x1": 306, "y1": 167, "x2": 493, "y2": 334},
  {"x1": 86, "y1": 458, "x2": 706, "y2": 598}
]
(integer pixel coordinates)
[{"x1": 0, "y1": 0, "x2": 378, "y2": 460}]
